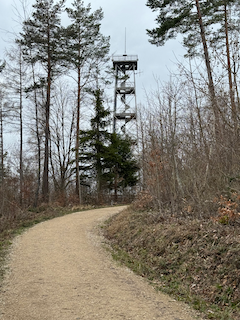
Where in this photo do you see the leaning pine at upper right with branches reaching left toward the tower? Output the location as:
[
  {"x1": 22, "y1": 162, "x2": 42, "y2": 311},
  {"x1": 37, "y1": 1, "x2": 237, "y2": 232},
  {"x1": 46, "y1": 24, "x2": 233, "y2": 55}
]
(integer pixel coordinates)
[{"x1": 147, "y1": 0, "x2": 219, "y2": 140}]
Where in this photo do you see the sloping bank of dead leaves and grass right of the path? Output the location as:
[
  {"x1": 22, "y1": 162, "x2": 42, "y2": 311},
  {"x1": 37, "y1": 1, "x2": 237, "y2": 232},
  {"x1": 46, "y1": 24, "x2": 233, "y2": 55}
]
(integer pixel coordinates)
[{"x1": 104, "y1": 207, "x2": 240, "y2": 320}]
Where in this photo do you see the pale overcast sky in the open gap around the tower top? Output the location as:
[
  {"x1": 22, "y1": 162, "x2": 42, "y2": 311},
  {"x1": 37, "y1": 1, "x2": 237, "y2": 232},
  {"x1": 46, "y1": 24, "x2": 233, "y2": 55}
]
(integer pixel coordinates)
[{"x1": 0, "y1": 0, "x2": 184, "y2": 102}]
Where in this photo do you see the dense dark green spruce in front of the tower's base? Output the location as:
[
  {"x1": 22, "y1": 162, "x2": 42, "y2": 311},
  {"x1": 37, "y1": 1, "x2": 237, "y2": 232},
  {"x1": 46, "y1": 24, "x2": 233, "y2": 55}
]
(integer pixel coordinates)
[{"x1": 79, "y1": 89, "x2": 139, "y2": 204}]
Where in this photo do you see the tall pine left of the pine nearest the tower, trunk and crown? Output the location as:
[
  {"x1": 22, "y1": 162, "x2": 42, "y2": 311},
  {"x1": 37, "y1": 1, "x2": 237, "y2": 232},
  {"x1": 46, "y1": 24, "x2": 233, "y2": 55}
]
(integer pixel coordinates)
[{"x1": 18, "y1": 0, "x2": 65, "y2": 202}]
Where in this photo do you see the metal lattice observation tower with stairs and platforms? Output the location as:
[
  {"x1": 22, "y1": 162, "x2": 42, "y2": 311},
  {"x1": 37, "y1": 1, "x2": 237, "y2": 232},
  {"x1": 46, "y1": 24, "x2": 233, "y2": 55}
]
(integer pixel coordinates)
[{"x1": 112, "y1": 54, "x2": 138, "y2": 133}]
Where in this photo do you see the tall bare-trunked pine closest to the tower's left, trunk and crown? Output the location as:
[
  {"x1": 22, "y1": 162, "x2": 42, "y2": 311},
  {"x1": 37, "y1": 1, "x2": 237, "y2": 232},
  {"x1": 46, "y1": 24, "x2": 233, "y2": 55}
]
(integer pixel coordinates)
[{"x1": 66, "y1": 0, "x2": 110, "y2": 202}]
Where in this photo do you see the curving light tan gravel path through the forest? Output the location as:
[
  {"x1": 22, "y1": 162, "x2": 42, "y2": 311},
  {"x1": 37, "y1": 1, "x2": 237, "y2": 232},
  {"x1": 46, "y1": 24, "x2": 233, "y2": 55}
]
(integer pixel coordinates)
[{"x1": 0, "y1": 207, "x2": 202, "y2": 320}]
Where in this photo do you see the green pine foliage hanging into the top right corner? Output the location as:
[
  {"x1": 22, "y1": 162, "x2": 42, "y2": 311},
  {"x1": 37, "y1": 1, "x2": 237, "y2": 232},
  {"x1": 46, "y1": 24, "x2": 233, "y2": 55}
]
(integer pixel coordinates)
[{"x1": 147, "y1": 0, "x2": 239, "y2": 56}]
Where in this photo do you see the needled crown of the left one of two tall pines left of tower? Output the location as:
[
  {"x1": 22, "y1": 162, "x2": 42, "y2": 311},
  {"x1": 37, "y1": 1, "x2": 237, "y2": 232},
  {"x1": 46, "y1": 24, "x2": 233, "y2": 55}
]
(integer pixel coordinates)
[{"x1": 17, "y1": 0, "x2": 66, "y2": 72}]
